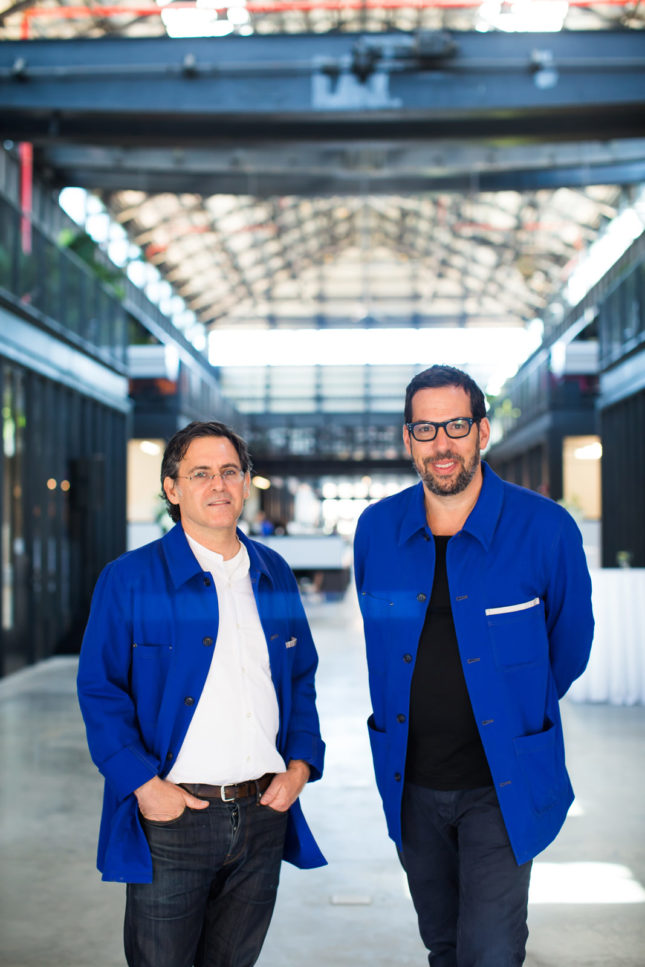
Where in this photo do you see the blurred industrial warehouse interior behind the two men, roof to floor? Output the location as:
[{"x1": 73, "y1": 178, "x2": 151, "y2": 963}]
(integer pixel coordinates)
[{"x1": 0, "y1": 0, "x2": 645, "y2": 967}]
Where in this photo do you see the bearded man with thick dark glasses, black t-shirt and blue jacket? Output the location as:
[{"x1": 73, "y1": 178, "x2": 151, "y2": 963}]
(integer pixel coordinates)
[{"x1": 355, "y1": 366, "x2": 593, "y2": 967}]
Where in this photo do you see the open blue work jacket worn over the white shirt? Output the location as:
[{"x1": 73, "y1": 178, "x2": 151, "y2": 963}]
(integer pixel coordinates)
[{"x1": 78, "y1": 523, "x2": 325, "y2": 883}]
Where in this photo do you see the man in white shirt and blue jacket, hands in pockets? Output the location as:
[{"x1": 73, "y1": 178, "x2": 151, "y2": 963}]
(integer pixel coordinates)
[{"x1": 78, "y1": 422, "x2": 325, "y2": 967}]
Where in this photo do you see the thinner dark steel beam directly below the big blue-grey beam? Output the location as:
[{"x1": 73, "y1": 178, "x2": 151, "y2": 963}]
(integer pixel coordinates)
[{"x1": 37, "y1": 138, "x2": 645, "y2": 198}]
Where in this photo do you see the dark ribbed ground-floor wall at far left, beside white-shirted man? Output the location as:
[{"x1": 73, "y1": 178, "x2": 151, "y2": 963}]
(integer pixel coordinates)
[{"x1": 0, "y1": 357, "x2": 127, "y2": 674}]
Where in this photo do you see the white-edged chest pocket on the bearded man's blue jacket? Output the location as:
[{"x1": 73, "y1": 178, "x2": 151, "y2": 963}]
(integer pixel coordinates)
[{"x1": 486, "y1": 598, "x2": 548, "y2": 667}]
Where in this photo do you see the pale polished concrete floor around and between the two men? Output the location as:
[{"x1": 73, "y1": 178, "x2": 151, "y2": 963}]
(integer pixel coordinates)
[{"x1": 0, "y1": 593, "x2": 645, "y2": 967}]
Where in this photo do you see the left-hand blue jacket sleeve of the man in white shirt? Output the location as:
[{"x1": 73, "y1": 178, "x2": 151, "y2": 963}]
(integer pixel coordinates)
[{"x1": 77, "y1": 562, "x2": 159, "y2": 799}]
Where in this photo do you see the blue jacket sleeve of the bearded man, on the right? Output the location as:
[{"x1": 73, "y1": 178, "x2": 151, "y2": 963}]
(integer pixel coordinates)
[{"x1": 545, "y1": 513, "x2": 594, "y2": 698}]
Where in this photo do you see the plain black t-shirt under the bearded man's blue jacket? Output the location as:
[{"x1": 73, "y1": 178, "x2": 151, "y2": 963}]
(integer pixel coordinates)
[{"x1": 405, "y1": 536, "x2": 492, "y2": 789}]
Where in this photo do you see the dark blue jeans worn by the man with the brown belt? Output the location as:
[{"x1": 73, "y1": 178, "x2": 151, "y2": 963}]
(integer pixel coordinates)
[{"x1": 124, "y1": 797, "x2": 287, "y2": 967}]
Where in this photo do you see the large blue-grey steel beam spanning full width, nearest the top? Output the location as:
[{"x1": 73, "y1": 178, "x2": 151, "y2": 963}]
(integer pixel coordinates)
[{"x1": 0, "y1": 30, "x2": 645, "y2": 148}]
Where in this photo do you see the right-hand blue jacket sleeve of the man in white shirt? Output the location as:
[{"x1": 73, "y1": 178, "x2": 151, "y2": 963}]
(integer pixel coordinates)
[{"x1": 284, "y1": 565, "x2": 325, "y2": 782}]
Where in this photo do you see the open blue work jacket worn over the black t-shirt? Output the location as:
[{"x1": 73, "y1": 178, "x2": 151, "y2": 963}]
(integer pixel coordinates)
[{"x1": 355, "y1": 463, "x2": 593, "y2": 863}]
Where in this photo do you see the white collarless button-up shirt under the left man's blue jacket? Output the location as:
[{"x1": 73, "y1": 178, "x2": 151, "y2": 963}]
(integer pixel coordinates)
[{"x1": 168, "y1": 535, "x2": 285, "y2": 786}]
